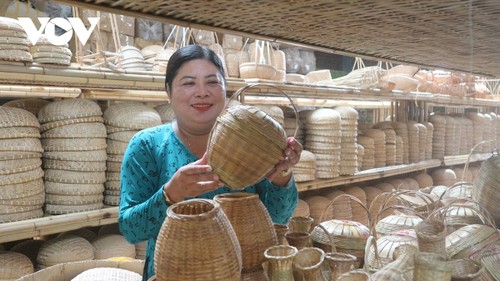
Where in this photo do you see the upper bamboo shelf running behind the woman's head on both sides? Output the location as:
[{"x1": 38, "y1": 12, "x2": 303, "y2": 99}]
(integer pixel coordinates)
[{"x1": 0, "y1": 64, "x2": 500, "y2": 108}]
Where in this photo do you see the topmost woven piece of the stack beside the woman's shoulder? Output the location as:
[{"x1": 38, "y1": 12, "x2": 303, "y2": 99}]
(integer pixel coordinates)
[{"x1": 103, "y1": 102, "x2": 162, "y2": 130}]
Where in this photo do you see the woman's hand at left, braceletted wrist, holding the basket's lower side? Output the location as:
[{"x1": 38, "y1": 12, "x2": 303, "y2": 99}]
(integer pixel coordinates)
[{"x1": 163, "y1": 153, "x2": 224, "y2": 202}]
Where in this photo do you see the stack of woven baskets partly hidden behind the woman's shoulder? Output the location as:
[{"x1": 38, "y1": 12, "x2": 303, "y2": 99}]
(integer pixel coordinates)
[{"x1": 103, "y1": 102, "x2": 162, "y2": 203}]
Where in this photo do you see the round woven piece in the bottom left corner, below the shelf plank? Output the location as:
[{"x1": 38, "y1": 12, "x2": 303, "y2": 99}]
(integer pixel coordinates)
[{"x1": 0, "y1": 251, "x2": 35, "y2": 280}]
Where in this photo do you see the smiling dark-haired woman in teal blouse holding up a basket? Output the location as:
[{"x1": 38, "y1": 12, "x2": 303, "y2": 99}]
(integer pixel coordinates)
[{"x1": 118, "y1": 45, "x2": 302, "y2": 280}]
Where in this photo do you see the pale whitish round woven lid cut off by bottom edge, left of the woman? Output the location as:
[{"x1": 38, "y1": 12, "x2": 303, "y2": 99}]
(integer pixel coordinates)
[{"x1": 71, "y1": 267, "x2": 142, "y2": 281}]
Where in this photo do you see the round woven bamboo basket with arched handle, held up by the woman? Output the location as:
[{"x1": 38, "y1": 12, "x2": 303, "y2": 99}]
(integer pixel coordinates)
[{"x1": 207, "y1": 84, "x2": 298, "y2": 189}]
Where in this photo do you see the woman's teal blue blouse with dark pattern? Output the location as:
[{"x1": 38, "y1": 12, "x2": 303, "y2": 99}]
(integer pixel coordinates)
[{"x1": 118, "y1": 123, "x2": 298, "y2": 280}]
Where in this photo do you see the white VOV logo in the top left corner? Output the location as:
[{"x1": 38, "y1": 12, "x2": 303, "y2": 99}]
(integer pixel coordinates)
[{"x1": 18, "y1": 17, "x2": 99, "y2": 46}]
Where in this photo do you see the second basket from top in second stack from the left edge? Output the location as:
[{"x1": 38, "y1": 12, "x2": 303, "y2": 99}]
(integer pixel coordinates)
[{"x1": 41, "y1": 122, "x2": 107, "y2": 139}]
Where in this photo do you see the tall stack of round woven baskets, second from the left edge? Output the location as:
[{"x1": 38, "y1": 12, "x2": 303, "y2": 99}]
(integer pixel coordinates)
[{"x1": 38, "y1": 99, "x2": 107, "y2": 214}]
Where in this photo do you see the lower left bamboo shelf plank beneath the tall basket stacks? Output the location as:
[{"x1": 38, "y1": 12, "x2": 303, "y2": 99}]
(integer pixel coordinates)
[{"x1": 0, "y1": 207, "x2": 118, "y2": 243}]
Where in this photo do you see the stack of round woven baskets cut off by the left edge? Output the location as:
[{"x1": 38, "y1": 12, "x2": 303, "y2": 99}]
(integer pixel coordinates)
[{"x1": 0, "y1": 106, "x2": 45, "y2": 222}]
